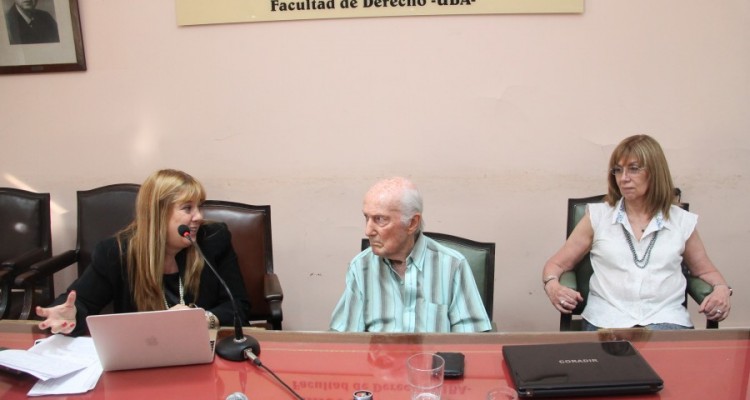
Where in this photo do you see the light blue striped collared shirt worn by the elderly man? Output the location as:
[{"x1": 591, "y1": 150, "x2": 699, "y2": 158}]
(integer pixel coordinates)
[{"x1": 330, "y1": 234, "x2": 492, "y2": 332}]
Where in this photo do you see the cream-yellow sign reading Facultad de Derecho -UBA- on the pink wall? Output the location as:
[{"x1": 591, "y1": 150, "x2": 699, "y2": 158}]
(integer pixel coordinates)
[{"x1": 175, "y1": 0, "x2": 584, "y2": 25}]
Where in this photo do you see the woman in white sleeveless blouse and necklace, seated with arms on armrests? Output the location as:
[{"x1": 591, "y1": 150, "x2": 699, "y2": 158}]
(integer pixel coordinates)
[{"x1": 542, "y1": 135, "x2": 732, "y2": 330}]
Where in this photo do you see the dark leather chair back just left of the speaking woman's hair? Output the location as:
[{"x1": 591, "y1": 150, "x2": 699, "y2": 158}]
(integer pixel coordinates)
[{"x1": 76, "y1": 183, "x2": 140, "y2": 276}]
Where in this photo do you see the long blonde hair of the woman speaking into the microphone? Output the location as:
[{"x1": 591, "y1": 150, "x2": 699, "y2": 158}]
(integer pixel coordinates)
[{"x1": 117, "y1": 169, "x2": 206, "y2": 311}]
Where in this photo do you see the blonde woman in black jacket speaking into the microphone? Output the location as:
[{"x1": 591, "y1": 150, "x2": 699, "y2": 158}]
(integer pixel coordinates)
[{"x1": 36, "y1": 169, "x2": 249, "y2": 335}]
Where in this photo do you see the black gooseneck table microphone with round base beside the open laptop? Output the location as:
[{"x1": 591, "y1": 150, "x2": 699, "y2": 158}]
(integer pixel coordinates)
[{"x1": 177, "y1": 225, "x2": 260, "y2": 361}]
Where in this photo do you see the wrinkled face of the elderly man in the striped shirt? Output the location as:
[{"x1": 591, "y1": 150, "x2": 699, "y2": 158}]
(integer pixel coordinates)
[{"x1": 362, "y1": 193, "x2": 420, "y2": 261}]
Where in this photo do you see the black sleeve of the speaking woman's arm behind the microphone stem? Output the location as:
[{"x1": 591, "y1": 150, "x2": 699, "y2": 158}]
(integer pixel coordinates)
[{"x1": 196, "y1": 223, "x2": 250, "y2": 326}]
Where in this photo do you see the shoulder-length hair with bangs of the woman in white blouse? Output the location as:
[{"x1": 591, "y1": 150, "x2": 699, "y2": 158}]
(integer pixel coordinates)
[{"x1": 604, "y1": 135, "x2": 675, "y2": 219}]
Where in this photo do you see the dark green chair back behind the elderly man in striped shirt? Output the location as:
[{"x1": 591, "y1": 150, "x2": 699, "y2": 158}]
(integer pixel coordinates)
[{"x1": 361, "y1": 232, "x2": 495, "y2": 320}]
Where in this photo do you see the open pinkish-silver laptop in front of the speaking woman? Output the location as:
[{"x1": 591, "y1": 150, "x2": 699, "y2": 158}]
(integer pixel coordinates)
[{"x1": 86, "y1": 308, "x2": 215, "y2": 371}]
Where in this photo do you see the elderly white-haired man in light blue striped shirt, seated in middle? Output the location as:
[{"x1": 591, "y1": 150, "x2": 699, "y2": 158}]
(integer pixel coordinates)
[{"x1": 331, "y1": 177, "x2": 492, "y2": 332}]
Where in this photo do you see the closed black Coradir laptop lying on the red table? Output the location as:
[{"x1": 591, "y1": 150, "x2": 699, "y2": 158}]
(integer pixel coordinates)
[{"x1": 503, "y1": 341, "x2": 664, "y2": 398}]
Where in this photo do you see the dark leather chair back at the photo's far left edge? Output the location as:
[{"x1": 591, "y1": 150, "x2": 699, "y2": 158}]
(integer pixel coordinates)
[{"x1": 0, "y1": 188, "x2": 52, "y2": 262}]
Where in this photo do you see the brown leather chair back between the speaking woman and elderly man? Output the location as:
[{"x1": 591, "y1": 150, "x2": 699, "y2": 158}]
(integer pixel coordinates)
[{"x1": 201, "y1": 200, "x2": 273, "y2": 321}]
